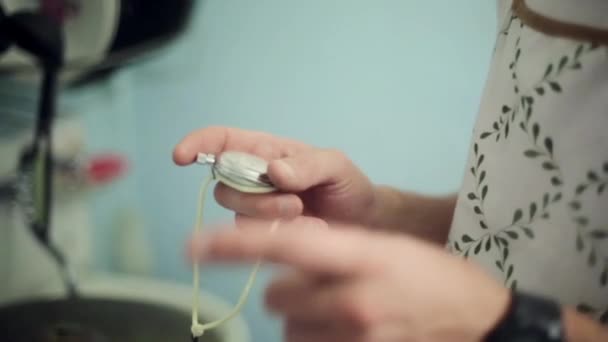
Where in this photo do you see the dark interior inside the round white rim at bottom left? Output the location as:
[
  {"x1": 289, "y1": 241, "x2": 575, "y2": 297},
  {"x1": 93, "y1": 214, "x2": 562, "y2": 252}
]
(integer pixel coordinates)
[{"x1": 0, "y1": 299, "x2": 221, "y2": 342}]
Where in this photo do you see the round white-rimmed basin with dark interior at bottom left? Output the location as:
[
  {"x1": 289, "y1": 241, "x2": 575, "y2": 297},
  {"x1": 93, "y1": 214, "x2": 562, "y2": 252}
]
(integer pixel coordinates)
[{"x1": 0, "y1": 274, "x2": 250, "y2": 342}]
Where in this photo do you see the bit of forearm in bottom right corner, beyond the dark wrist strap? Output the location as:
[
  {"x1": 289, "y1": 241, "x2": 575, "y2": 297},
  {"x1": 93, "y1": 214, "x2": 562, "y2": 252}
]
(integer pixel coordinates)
[{"x1": 564, "y1": 309, "x2": 608, "y2": 342}]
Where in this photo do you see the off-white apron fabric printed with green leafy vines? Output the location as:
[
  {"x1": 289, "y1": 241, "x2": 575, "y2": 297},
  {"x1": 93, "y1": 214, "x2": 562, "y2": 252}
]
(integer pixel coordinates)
[{"x1": 448, "y1": 0, "x2": 608, "y2": 323}]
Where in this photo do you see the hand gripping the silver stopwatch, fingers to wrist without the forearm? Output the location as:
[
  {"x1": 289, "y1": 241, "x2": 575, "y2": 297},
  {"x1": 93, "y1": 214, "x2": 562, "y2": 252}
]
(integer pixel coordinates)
[{"x1": 173, "y1": 127, "x2": 377, "y2": 228}]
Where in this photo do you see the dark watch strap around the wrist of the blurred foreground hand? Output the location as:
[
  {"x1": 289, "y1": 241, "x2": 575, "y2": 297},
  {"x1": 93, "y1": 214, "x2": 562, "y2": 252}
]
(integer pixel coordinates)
[{"x1": 485, "y1": 292, "x2": 566, "y2": 342}]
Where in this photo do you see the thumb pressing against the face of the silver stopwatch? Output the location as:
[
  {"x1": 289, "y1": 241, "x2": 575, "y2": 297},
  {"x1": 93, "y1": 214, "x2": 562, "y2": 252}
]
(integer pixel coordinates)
[{"x1": 268, "y1": 149, "x2": 363, "y2": 192}]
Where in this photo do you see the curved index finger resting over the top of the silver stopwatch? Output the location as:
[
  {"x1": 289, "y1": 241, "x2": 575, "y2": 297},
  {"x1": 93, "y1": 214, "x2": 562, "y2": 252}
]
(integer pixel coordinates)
[{"x1": 173, "y1": 126, "x2": 306, "y2": 165}]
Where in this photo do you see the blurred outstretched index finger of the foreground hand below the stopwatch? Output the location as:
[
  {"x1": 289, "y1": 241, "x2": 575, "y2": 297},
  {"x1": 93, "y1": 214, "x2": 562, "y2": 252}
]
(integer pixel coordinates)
[{"x1": 192, "y1": 225, "x2": 377, "y2": 276}]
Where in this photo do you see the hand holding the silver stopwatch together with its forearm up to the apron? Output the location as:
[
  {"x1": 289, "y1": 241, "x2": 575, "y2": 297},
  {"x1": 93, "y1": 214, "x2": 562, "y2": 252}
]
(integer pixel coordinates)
[{"x1": 173, "y1": 127, "x2": 455, "y2": 243}]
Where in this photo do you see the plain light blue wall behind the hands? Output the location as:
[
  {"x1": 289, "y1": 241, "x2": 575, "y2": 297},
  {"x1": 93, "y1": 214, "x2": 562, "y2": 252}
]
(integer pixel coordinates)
[{"x1": 0, "y1": 0, "x2": 497, "y2": 342}]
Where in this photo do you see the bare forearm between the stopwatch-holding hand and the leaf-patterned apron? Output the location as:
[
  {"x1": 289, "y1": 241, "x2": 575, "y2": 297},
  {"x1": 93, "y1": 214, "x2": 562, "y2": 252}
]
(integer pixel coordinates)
[{"x1": 368, "y1": 186, "x2": 456, "y2": 244}]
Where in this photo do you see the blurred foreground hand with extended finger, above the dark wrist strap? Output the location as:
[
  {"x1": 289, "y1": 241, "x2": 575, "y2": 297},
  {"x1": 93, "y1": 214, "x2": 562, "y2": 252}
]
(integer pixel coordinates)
[{"x1": 189, "y1": 220, "x2": 509, "y2": 342}]
